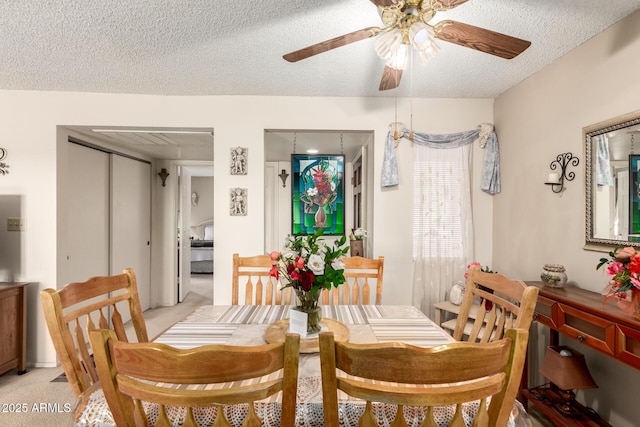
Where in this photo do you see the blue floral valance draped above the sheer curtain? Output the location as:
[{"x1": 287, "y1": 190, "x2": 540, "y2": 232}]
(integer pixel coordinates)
[{"x1": 382, "y1": 124, "x2": 500, "y2": 194}]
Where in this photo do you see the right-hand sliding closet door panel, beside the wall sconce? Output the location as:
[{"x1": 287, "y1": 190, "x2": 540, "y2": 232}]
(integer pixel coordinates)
[{"x1": 111, "y1": 154, "x2": 151, "y2": 310}]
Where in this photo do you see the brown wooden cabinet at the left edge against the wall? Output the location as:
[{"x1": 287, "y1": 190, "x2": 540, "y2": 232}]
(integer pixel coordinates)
[{"x1": 0, "y1": 282, "x2": 27, "y2": 374}]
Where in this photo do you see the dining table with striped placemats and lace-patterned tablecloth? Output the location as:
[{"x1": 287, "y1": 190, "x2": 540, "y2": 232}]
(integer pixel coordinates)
[{"x1": 74, "y1": 305, "x2": 520, "y2": 427}]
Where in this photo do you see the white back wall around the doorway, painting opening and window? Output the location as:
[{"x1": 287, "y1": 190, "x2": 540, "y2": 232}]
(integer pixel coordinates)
[{"x1": 0, "y1": 91, "x2": 493, "y2": 365}]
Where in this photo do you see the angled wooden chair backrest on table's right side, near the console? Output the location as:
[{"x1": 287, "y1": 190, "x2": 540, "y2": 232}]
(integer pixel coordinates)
[{"x1": 453, "y1": 267, "x2": 539, "y2": 342}]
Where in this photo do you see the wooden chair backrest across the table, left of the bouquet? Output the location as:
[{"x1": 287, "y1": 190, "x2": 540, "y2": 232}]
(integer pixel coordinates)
[{"x1": 231, "y1": 254, "x2": 292, "y2": 305}]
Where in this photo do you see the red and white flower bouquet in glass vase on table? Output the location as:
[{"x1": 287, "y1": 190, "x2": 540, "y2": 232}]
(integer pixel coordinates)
[{"x1": 270, "y1": 228, "x2": 349, "y2": 334}]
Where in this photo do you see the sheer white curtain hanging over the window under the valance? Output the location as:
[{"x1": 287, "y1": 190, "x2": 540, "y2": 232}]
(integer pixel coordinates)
[{"x1": 413, "y1": 144, "x2": 473, "y2": 318}]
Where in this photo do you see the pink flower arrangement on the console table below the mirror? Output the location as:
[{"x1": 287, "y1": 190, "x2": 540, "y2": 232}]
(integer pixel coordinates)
[{"x1": 596, "y1": 246, "x2": 640, "y2": 319}]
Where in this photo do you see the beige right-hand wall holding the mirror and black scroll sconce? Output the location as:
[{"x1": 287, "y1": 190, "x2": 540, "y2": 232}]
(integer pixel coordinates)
[{"x1": 493, "y1": 12, "x2": 640, "y2": 427}]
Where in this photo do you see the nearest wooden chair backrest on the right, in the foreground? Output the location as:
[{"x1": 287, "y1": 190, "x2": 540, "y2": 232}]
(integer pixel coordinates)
[{"x1": 320, "y1": 329, "x2": 529, "y2": 427}]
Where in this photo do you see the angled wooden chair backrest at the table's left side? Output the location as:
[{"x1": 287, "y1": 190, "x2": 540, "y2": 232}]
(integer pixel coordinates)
[{"x1": 40, "y1": 269, "x2": 149, "y2": 395}]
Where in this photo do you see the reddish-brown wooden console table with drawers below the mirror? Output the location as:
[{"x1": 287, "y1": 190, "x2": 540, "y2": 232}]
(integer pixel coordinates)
[{"x1": 522, "y1": 282, "x2": 640, "y2": 426}]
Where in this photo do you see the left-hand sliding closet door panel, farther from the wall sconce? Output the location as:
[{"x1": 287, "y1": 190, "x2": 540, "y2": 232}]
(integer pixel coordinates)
[{"x1": 65, "y1": 142, "x2": 109, "y2": 286}]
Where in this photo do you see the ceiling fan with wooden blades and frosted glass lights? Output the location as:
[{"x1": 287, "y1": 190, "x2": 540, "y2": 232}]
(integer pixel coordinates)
[{"x1": 283, "y1": 0, "x2": 531, "y2": 90}]
